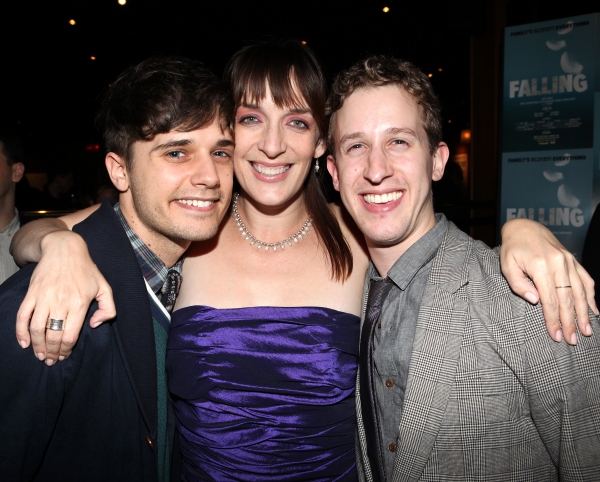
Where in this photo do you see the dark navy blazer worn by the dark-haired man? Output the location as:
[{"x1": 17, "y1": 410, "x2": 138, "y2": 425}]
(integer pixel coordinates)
[{"x1": 0, "y1": 202, "x2": 169, "y2": 481}]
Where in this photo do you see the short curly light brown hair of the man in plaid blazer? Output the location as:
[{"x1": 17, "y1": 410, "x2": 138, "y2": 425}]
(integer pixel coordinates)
[{"x1": 327, "y1": 55, "x2": 442, "y2": 156}]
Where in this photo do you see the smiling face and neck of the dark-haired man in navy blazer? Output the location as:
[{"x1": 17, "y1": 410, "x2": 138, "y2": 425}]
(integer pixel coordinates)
[{"x1": 117, "y1": 120, "x2": 233, "y2": 254}]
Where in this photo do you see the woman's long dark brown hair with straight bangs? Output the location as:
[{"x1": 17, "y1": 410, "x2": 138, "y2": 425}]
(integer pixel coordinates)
[{"x1": 225, "y1": 39, "x2": 352, "y2": 281}]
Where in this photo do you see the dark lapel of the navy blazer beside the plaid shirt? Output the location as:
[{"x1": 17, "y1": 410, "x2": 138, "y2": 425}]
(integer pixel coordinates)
[{"x1": 73, "y1": 201, "x2": 158, "y2": 436}]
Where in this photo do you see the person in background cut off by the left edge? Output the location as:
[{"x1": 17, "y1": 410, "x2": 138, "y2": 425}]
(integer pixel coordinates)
[{"x1": 0, "y1": 132, "x2": 25, "y2": 283}]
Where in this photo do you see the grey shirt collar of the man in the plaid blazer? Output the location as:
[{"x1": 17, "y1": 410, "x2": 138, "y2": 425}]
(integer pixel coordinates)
[{"x1": 369, "y1": 214, "x2": 448, "y2": 290}]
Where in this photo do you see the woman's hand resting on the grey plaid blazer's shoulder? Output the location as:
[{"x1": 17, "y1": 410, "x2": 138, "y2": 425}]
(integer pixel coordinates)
[{"x1": 500, "y1": 219, "x2": 598, "y2": 345}]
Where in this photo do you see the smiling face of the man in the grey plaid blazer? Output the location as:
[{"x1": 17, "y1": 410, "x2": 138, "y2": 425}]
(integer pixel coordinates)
[{"x1": 328, "y1": 85, "x2": 448, "y2": 255}]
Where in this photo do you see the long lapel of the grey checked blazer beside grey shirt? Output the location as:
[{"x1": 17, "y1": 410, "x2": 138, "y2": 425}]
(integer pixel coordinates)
[{"x1": 392, "y1": 223, "x2": 472, "y2": 481}]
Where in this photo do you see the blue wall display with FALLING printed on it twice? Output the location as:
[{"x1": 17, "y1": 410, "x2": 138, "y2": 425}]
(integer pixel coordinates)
[{"x1": 500, "y1": 14, "x2": 600, "y2": 260}]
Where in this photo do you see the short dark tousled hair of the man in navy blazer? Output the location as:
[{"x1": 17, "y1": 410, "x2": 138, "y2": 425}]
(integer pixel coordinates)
[{"x1": 97, "y1": 57, "x2": 233, "y2": 167}]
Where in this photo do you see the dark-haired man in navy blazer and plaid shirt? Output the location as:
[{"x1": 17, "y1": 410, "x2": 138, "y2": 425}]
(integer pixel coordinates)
[{"x1": 0, "y1": 58, "x2": 233, "y2": 481}]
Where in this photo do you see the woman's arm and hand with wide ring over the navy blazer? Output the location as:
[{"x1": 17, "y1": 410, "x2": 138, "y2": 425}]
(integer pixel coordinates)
[{"x1": 10, "y1": 206, "x2": 116, "y2": 365}]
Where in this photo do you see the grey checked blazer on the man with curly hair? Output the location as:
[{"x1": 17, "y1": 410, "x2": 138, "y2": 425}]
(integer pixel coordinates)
[{"x1": 357, "y1": 223, "x2": 600, "y2": 482}]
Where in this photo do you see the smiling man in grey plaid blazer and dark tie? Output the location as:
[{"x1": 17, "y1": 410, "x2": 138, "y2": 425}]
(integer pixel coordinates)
[{"x1": 328, "y1": 57, "x2": 600, "y2": 482}]
